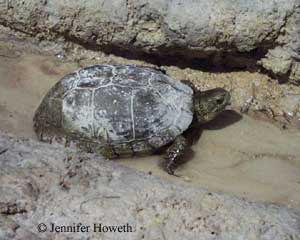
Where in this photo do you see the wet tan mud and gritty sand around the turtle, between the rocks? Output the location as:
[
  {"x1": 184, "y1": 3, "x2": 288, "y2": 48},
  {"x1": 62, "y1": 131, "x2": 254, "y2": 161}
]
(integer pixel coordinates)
[{"x1": 0, "y1": 35, "x2": 300, "y2": 207}]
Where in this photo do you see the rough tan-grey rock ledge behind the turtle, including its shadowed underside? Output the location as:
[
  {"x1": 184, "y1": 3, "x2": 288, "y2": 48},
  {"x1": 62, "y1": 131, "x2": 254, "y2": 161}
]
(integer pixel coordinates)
[{"x1": 0, "y1": 0, "x2": 300, "y2": 84}]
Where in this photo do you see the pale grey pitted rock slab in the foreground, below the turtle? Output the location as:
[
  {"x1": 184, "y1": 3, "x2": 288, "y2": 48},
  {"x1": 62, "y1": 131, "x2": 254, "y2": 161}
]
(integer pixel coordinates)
[{"x1": 0, "y1": 132, "x2": 300, "y2": 240}]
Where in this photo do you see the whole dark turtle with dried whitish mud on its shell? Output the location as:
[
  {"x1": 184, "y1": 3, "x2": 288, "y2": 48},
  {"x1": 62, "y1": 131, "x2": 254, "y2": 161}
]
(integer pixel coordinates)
[{"x1": 33, "y1": 64, "x2": 230, "y2": 175}]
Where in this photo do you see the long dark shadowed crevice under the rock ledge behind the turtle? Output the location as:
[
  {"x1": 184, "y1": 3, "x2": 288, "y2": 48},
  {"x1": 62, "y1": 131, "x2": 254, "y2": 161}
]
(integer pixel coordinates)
[{"x1": 64, "y1": 34, "x2": 268, "y2": 73}]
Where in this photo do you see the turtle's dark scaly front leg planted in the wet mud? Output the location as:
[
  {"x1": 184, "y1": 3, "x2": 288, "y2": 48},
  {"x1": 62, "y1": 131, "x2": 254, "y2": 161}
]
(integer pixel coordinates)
[{"x1": 164, "y1": 135, "x2": 188, "y2": 175}]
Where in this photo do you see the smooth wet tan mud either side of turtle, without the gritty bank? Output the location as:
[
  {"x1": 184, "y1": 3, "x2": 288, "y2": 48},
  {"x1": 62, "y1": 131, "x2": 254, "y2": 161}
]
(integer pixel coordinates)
[{"x1": 0, "y1": 46, "x2": 300, "y2": 207}]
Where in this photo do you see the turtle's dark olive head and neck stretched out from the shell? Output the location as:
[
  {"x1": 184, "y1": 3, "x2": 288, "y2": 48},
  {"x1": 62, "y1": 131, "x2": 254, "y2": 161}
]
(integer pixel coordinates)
[{"x1": 194, "y1": 88, "x2": 230, "y2": 123}]
